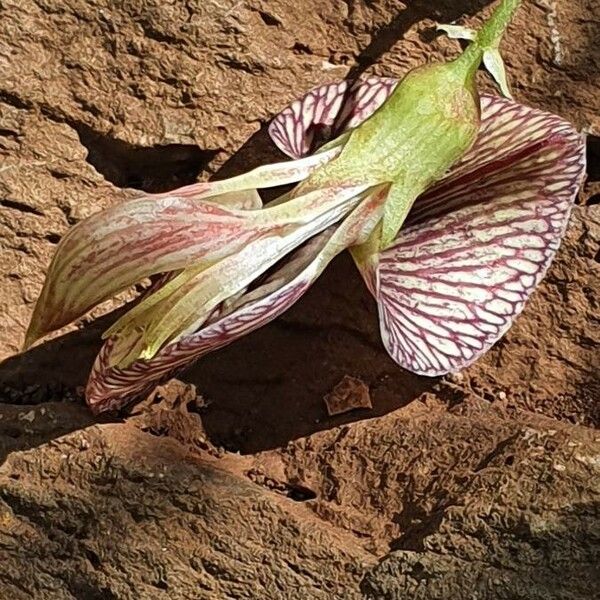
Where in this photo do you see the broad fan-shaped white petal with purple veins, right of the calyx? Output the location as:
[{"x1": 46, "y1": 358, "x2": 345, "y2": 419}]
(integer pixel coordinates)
[{"x1": 370, "y1": 97, "x2": 585, "y2": 376}]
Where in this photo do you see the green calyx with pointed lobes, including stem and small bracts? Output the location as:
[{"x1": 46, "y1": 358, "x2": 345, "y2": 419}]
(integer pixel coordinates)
[{"x1": 299, "y1": 0, "x2": 520, "y2": 255}]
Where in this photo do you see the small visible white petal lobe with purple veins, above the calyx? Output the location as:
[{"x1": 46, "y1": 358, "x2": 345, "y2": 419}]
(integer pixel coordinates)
[{"x1": 269, "y1": 77, "x2": 398, "y2": 159}]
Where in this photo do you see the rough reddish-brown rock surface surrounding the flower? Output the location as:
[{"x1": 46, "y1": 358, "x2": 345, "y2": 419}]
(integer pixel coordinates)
[{"x1": 0, "y1": 0, "x2": 600, "y2": 600}]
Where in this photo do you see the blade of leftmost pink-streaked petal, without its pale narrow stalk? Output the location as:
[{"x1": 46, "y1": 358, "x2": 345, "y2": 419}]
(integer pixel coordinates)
[{"x1": 28, "y1": 196, "x2": 258, "y2": 345}]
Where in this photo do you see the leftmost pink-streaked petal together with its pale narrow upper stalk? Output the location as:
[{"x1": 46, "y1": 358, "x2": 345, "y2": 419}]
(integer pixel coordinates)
[{"x1": 26, "y1": 149, "x2": 338, "y2": 346}]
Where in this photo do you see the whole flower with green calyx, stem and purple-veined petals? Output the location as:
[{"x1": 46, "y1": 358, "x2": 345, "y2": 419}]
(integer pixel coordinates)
[{"x1": 28, "y1": 0, "x2": 585, "y2": 412}]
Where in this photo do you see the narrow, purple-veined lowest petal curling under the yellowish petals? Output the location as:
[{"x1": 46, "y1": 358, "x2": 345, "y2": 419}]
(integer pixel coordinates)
[{"x1": 86, "y1": 188, "x2": 387, "y2": 413}]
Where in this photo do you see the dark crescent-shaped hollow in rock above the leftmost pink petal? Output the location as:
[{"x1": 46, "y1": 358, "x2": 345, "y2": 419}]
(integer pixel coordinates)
[{"x1": 74, "y1": 123, "x2": 219, "y2": 193}]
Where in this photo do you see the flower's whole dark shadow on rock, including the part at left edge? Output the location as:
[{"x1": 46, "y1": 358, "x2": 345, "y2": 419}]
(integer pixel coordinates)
[{"x1": 0, "y1": 255, "x2": 437, "y2": 453}]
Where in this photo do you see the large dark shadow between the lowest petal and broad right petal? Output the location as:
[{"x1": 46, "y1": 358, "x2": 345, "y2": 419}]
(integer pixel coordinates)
[{"x1": 185, "y1": 254, "x2": 437, "y2": 453}]
